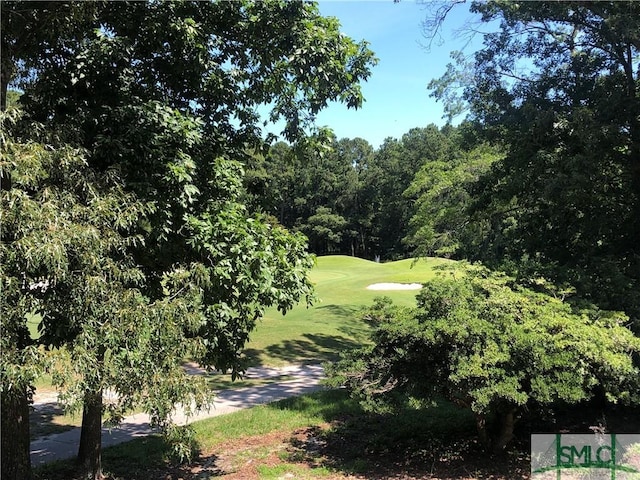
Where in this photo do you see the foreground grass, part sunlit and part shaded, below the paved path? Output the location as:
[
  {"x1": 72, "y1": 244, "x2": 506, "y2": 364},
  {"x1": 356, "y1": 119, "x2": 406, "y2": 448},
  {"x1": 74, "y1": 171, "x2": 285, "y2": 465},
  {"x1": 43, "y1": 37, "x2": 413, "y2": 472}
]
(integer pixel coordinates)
[{"x1": 35, "y1": 390, "x2": 474, "y2": 480}]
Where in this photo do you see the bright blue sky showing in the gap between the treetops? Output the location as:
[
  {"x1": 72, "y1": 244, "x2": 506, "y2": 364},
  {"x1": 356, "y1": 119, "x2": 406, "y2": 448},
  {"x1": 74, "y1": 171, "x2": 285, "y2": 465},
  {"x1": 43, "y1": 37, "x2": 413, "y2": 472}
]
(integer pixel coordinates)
[{"x1": 317, "y1": 0, "x2": 480, "y2": 148}]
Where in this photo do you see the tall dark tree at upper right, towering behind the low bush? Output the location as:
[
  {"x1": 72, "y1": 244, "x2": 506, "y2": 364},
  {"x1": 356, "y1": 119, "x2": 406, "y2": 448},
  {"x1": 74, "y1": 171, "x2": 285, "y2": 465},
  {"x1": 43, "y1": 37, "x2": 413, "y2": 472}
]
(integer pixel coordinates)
[{"x1": 434, "y1": 1, "x2": 640, "y2": 319}]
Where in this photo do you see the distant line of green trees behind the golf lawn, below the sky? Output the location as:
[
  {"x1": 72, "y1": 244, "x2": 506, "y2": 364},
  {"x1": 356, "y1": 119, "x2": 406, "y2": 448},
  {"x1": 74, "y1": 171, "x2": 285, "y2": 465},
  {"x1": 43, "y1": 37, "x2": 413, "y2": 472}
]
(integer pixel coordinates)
[{"x1": 245, "y1": 124, "x2": 497, "y2": 261}]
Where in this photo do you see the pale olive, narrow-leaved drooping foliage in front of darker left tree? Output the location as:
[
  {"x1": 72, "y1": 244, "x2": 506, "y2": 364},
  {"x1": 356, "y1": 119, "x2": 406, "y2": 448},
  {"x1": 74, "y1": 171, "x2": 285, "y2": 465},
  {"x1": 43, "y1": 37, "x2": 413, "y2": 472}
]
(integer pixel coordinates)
[{"x1": 0, "y1": 112, "x2": 206, "y2": 478}]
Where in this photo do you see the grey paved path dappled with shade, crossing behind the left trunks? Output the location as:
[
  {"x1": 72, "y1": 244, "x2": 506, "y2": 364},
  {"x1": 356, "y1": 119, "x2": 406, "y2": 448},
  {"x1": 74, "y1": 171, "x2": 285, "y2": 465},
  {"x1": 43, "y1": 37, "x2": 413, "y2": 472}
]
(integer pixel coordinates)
[{"x1": 31, "y1": 365, "x2": 324, "y2": 466}]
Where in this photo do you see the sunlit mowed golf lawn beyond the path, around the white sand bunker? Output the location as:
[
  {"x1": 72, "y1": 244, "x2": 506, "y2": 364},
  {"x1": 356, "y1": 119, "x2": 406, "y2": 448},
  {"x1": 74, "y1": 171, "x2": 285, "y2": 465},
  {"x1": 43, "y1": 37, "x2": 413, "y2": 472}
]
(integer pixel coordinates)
[{"x1": 246, "y1": 255, "x2": 451, "y2": 366}]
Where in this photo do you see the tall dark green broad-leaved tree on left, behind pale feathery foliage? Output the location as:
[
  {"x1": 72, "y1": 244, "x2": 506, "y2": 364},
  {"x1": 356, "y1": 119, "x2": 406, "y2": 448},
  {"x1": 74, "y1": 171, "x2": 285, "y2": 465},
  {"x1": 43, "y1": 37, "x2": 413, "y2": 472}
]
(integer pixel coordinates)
[{"x1": 2, "y1": 1, "x2": 374, "y2": 478}]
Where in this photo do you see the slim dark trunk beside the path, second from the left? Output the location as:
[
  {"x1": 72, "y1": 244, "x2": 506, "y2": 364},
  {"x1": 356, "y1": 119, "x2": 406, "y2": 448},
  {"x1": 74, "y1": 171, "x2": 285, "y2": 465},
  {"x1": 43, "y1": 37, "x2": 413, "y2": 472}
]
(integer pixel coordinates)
[{"x1": 77, "y1": 390, "x2": 104, "y2": 480}]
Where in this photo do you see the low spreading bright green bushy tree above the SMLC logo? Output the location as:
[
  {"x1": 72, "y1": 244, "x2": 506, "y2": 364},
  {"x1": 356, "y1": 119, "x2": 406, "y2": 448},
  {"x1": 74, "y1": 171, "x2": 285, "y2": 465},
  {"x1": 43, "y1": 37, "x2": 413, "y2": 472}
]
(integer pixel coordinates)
[{"x1": 330, "y1": 268, "x2": 640, "y2": 451}]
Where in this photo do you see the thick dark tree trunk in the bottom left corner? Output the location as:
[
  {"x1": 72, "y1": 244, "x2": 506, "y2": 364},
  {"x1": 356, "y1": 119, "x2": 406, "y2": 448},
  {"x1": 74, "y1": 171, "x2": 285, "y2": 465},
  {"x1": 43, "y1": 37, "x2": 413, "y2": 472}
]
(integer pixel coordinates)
[{"x1": 0, "y1": 386, "x2": 31, "y2": 480}]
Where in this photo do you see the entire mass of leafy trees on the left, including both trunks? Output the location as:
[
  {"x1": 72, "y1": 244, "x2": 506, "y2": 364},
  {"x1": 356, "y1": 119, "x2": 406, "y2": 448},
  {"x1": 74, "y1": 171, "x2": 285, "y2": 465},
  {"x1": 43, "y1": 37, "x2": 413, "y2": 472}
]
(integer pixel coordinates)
[{"x1": 0, "y1": 1, "x2": 374, "y2": 479}]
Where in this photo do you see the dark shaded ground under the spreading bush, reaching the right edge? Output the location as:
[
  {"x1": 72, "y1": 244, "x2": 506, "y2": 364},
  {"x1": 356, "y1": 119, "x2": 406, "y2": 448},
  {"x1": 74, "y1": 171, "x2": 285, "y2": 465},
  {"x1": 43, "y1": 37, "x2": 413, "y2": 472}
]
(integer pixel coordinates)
[{"x1": 278, "y1": 390, "x2": 640, "y2": 480}]
